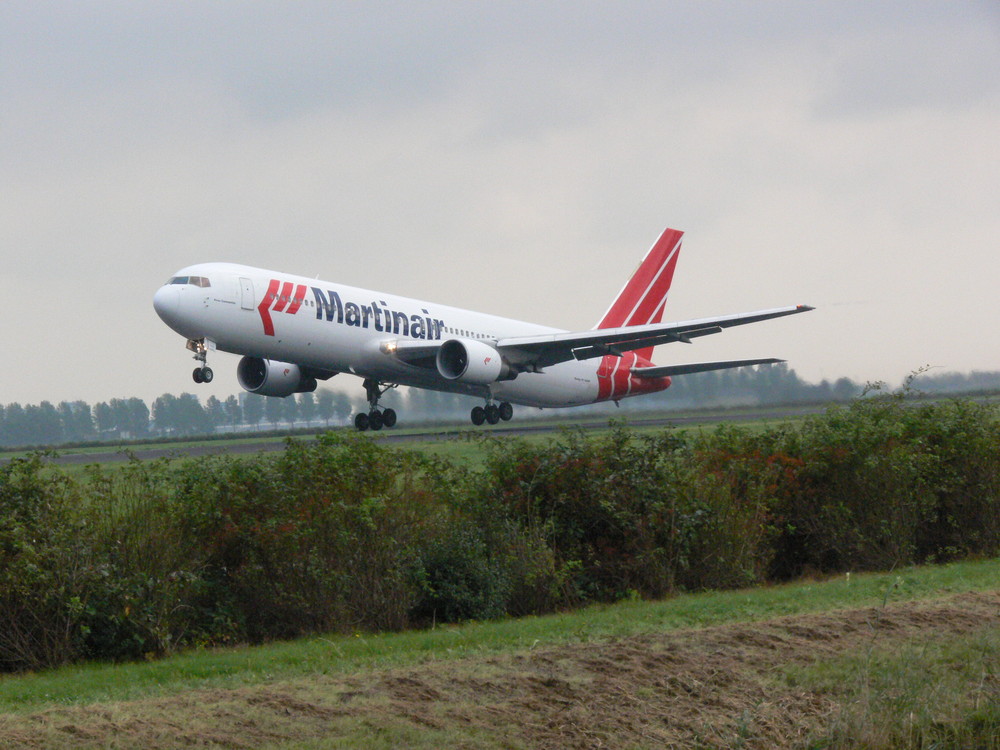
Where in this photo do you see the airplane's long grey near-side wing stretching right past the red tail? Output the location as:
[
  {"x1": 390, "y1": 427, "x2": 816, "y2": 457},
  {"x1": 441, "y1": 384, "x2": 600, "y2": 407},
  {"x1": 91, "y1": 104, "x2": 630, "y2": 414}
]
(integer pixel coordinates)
[{"x1": 496, "y1": 305, "x2": 814, "y2": 377}]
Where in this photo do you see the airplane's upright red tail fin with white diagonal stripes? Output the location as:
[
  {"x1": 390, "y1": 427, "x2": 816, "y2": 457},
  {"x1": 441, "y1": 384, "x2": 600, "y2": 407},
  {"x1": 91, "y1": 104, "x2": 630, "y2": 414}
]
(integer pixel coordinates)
[{"x1": 597, "y1": 229, "x2": 684, "y2": 346}]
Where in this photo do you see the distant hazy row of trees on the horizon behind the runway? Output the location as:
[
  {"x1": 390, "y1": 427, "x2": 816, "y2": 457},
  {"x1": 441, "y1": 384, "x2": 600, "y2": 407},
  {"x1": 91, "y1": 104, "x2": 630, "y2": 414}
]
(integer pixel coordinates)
[{"x1": 0, "y1": 363, "x2": 1000, "y2": 447}]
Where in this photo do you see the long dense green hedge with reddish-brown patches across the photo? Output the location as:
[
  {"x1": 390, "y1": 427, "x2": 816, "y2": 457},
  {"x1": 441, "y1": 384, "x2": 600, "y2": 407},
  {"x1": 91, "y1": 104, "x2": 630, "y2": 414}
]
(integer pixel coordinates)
[{"x1": 0, "y1": 396, "x2": 1000, "y2": 671}]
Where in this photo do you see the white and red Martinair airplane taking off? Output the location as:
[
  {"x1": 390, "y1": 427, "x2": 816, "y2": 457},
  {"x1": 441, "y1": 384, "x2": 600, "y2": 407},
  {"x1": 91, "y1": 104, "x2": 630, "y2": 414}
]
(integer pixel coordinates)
[{"x1": 153, "y1": 228, "x2": 814, "y2": 431}]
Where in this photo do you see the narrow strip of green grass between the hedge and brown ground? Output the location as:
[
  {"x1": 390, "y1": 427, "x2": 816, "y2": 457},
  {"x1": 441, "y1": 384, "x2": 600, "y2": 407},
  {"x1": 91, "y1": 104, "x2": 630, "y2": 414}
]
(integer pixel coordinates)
[{"x1": 0, "y1": 560, "x2": 1000, "y2": 713}]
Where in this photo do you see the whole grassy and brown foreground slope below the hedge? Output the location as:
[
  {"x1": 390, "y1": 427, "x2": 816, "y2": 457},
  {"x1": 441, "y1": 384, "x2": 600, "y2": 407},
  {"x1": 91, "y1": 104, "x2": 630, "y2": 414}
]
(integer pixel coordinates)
[{"x1": 0, "y1": 560, "x2": 1000, "y2": 750}]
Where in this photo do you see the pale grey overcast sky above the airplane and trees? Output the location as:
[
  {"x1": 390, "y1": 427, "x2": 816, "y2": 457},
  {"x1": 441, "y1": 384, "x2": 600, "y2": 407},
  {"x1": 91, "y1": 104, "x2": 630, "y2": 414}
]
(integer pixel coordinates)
[{"x1": 0, "y1": 0, "x2": 1000, "y2": 412}]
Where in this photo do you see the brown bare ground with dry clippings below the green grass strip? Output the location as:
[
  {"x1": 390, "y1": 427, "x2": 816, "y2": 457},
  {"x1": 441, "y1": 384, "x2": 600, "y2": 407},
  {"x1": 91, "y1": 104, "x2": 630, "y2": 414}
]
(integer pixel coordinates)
[{"x1": 0, "y1": 591, "x2": 1000, "y2": 750}]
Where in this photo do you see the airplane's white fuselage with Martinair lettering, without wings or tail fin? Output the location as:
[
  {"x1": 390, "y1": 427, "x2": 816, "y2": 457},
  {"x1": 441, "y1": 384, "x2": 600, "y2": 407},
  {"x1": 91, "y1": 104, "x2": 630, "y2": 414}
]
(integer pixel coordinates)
[{"x1": 154, "y1": 263, "x2": 640, "y2": 407}]
